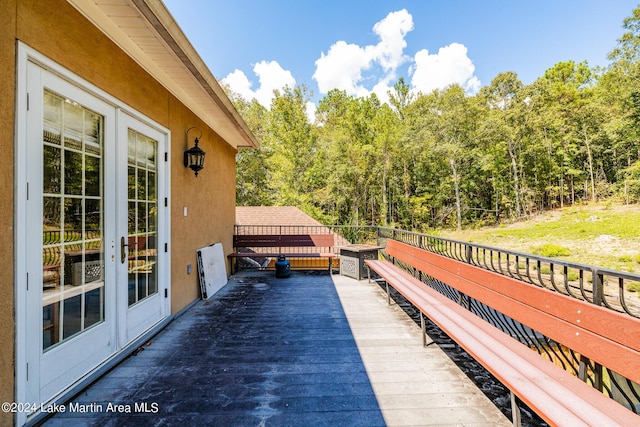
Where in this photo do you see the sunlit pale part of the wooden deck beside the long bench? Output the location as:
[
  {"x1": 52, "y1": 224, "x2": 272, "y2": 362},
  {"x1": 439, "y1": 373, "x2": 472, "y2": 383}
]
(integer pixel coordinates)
[{"x1": 334, "y1": 275, "x2": 512, "y2": 427}]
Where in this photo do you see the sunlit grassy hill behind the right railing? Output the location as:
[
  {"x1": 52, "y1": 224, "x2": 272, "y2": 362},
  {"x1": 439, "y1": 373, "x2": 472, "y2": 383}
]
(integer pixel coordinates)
[{"x1": 434, "y1": 202, "x2": 640, "y2": 273}]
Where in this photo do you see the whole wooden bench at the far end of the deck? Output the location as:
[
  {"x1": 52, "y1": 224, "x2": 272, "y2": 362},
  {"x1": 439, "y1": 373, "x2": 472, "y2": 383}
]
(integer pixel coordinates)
[{"x1": 227, "y1": 234, "x2": 336, "y2": 273}]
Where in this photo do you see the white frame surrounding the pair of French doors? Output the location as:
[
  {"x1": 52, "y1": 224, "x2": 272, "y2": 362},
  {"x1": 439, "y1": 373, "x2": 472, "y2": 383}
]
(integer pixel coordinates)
[{"x1": 14, "y1": 42, "x2": 171, "y2": 425}]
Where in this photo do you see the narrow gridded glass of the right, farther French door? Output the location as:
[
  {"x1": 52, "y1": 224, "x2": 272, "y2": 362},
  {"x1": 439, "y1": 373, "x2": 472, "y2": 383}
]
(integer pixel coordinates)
[{"x1": 127, "y1": 129, "x2": 158, "y2": 306}]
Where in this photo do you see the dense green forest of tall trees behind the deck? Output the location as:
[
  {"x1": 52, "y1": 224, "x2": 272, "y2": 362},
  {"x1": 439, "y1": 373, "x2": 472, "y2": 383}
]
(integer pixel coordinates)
[{"x1": 229, "y1": 7, "x2": 640, "y2": 231}]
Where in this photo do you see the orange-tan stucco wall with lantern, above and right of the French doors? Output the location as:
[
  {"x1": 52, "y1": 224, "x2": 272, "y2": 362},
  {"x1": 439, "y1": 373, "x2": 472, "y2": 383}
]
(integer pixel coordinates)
[{"x1": 12, "y1": 0, "x2": 235, "y2": 312}]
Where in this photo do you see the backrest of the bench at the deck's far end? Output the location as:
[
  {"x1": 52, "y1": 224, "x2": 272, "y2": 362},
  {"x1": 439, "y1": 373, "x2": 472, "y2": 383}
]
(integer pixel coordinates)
[{"x1": 233, "y1": 234, "x2": 335, "y2": 248}]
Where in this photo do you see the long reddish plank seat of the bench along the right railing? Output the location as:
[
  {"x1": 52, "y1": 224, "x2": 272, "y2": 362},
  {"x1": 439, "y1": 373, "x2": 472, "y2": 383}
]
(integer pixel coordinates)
[{"x1": 365, "y1": 260, "x2": 640, "y2": 426}]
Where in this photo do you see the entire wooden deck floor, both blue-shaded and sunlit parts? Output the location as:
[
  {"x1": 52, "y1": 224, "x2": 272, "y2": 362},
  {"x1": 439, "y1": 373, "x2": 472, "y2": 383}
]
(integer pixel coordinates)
[{"x1": 44, "y1": 271, "x2": 510, "y2": 427}]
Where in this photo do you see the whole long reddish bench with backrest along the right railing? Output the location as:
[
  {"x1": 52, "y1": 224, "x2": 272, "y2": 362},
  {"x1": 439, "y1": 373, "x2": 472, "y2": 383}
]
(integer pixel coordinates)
[{"x1": 365, "y1": 239, "x2": 640, "y2": 426}]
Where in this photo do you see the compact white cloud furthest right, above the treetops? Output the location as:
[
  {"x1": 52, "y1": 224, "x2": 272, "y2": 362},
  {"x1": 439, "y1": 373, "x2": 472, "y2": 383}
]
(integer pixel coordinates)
[{"x1": 410, "y1": 43, "x2": 480, "y2": 94}]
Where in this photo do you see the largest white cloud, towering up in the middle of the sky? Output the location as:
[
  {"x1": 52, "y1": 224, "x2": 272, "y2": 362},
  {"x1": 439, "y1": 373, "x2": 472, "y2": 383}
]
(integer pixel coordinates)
[{"x1": 313, "y1": 9, "x2": 413, "y2": 97}]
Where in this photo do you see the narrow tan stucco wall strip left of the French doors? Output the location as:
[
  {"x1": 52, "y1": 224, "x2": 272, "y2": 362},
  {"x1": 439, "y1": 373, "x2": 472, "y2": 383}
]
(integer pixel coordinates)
[{"x1": 0, "y1": 0, "x2": 17, "y2": 426}]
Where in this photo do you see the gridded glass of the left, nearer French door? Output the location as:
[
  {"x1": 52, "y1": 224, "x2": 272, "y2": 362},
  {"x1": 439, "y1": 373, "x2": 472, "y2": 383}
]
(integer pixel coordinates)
[{"x1": 42, "y1": 90, "x2": 104, "y2": 351}]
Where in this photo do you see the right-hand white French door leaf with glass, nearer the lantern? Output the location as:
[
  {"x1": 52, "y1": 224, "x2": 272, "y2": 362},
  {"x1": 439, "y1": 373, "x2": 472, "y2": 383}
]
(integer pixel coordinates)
[{"x1": 116, "y1": 113, "x2": 168, "y2": 346}]
